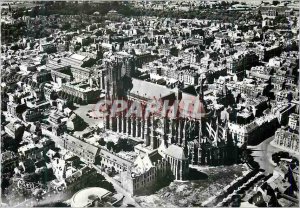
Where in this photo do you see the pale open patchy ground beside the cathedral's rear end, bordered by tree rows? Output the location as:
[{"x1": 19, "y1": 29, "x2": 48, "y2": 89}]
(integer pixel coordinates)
[{"x1": 135, "y1": 164, "x2": 249, "y2": 207}]
